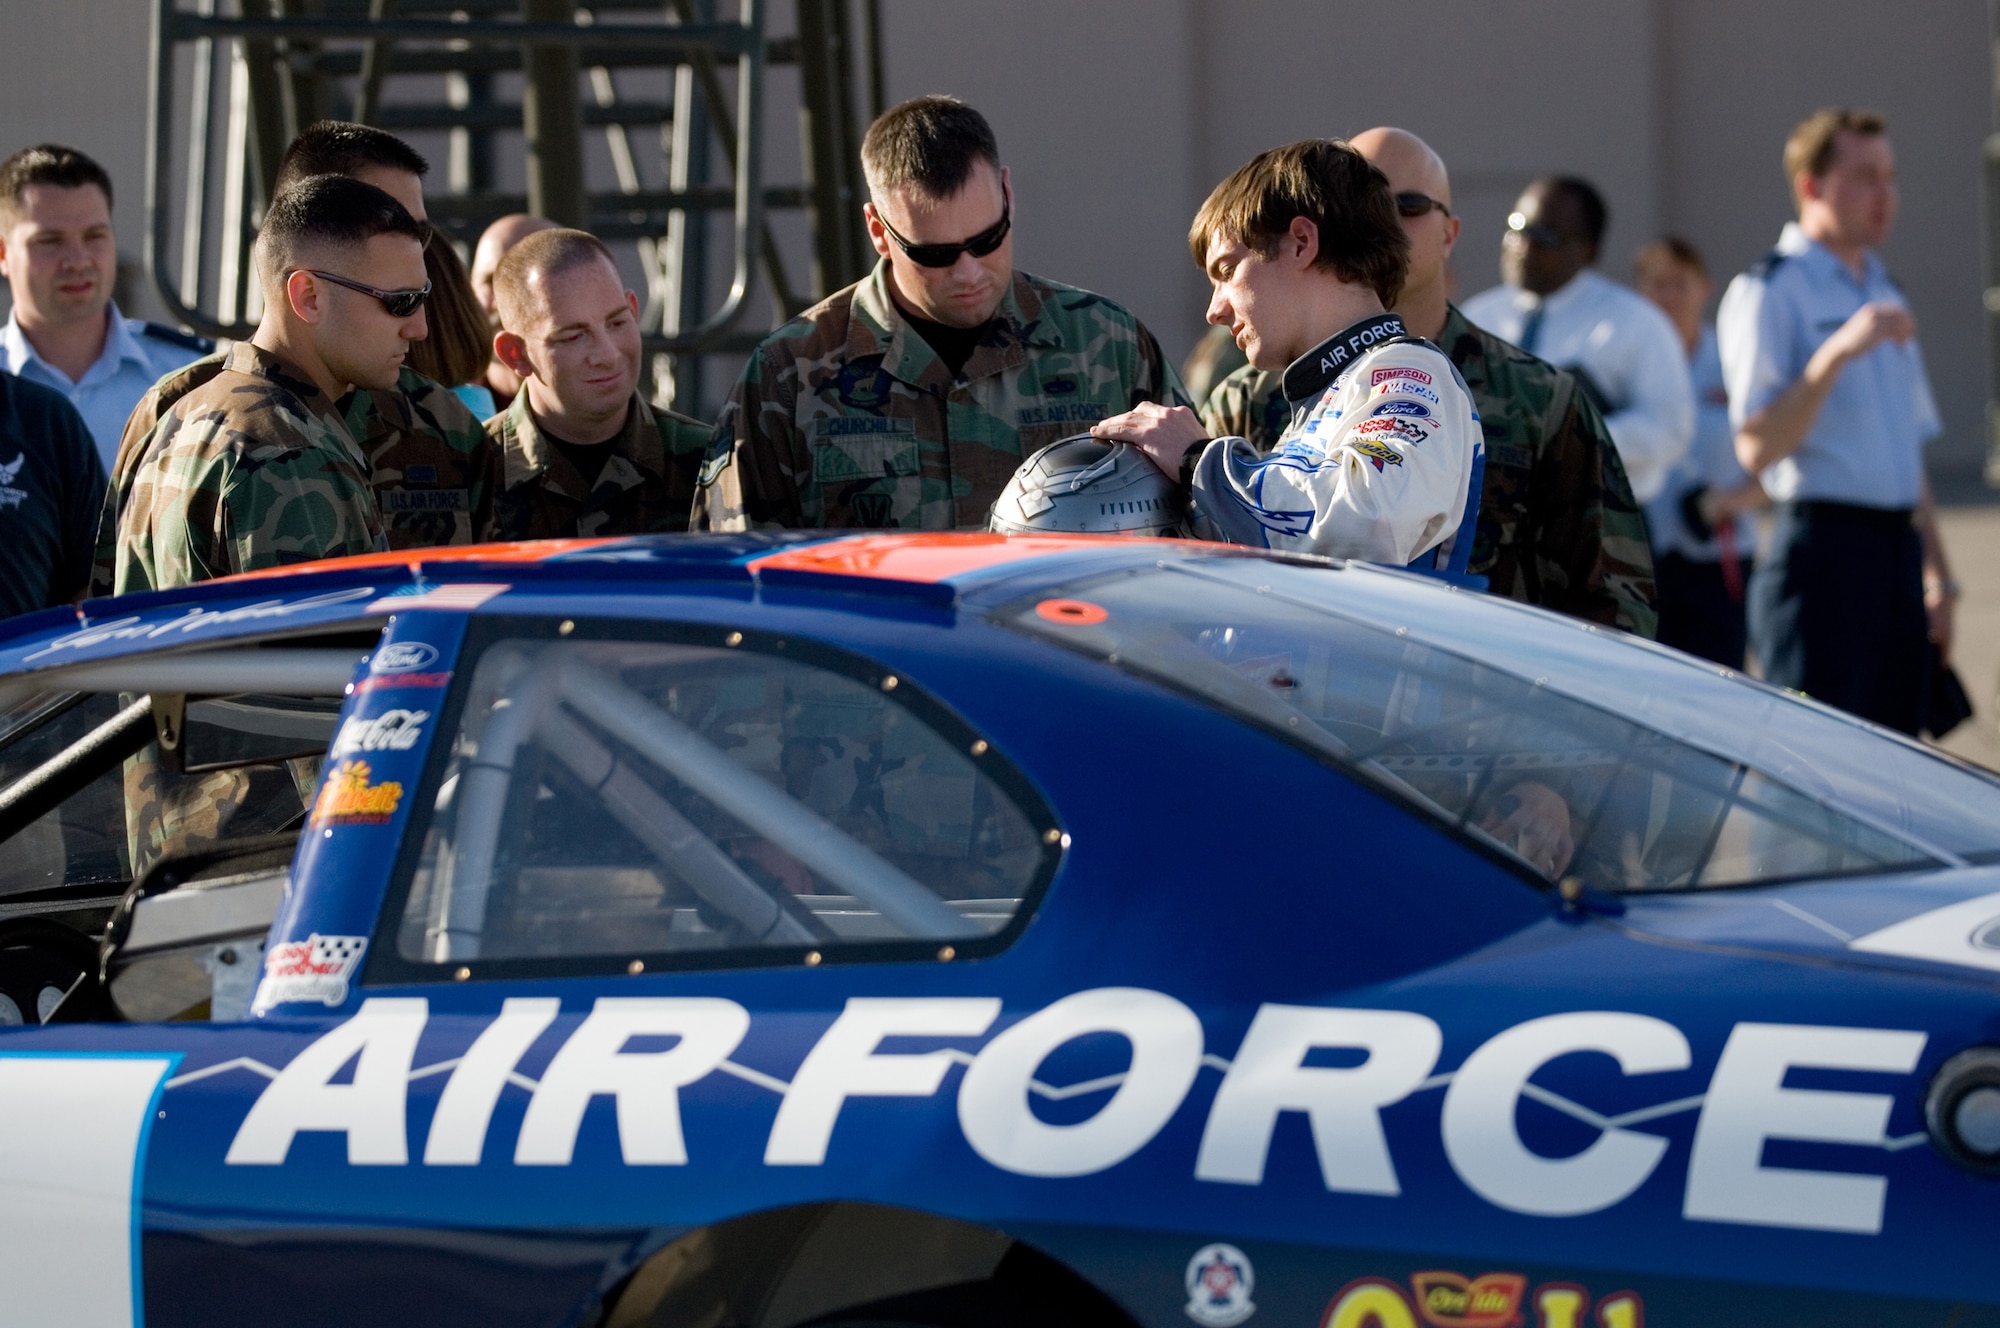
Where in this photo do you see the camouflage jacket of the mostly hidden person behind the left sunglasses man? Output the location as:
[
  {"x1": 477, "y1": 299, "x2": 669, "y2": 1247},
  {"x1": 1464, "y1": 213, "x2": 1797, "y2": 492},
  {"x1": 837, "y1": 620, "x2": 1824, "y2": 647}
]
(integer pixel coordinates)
[{"x1": 90, "y1": 354, "x2": 500, "y2": 596}]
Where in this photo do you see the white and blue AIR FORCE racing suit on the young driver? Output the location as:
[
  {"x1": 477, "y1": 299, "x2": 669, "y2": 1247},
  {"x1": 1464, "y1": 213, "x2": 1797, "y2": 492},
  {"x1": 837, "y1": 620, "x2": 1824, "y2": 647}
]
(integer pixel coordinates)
[{"x1": 1194, "y1": 314, "x2": 1486, "y2": 574}]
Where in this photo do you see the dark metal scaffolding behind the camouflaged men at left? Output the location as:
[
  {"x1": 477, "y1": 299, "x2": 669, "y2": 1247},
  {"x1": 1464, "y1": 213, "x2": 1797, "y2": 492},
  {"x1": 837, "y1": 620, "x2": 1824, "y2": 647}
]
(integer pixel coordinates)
[{"x1": 144, "y1": 0, "x2": 882, "y2": 414}]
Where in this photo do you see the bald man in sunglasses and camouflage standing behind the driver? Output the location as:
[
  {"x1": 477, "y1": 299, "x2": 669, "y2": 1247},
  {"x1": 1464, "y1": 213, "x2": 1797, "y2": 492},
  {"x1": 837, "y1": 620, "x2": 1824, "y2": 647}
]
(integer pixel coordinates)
[{"x1": 1202, "y1": 128, "x2": 1658, "y2": 636}]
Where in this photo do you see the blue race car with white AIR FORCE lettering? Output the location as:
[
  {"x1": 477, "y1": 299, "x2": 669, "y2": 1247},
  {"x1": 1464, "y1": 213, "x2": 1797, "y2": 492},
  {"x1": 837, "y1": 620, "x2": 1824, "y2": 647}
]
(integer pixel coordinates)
[{"x1": 0, "y1": 536, "x2": 2000, "y2": 1328}]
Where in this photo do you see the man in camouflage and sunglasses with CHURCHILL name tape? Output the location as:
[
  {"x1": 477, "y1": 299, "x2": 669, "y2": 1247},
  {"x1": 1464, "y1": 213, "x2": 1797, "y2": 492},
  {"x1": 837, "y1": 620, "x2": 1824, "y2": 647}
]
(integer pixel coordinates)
[{"x1": 694, "y1": 96, "x2": 1186, "y2": 530}]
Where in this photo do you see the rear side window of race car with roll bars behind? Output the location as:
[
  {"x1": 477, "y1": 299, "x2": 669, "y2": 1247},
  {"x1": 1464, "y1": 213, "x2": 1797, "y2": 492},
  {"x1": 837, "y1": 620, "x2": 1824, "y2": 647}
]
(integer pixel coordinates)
[{"x1": 378, "y1": 624, "x2": 1060, "y2": 978}]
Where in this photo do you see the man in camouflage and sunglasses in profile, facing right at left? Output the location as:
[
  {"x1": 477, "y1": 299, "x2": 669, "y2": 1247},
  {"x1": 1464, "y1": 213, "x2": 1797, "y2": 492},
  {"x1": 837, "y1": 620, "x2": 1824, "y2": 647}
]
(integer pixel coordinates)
[{"x1": 114, "y1": 176, "x2": 426, "y2": 594}]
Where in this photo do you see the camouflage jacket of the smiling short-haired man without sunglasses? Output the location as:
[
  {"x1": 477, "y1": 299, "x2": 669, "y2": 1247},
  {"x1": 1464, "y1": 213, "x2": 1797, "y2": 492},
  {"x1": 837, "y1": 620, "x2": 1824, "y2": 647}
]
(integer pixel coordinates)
[{"x1": 486, "y1": 392, "x2": 710, "y2": 540}]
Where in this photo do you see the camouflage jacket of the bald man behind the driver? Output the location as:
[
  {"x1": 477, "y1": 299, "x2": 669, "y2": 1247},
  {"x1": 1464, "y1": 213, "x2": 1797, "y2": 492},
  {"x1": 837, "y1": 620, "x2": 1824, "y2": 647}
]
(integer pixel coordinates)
[{"x1": 1202, "y1": 306, "x2": 1658, "y2": 636}]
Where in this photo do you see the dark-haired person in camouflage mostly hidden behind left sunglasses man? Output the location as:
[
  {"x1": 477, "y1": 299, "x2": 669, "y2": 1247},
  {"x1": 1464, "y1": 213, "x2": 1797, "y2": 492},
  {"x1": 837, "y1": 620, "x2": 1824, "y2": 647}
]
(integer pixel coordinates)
[{"x1": 90, "y1": 120, "x2": 500, "y2": 596}]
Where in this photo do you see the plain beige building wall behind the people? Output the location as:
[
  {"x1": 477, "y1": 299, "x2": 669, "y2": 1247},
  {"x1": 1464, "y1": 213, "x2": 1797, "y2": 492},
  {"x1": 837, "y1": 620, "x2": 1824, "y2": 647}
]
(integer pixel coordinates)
[{"x1": 0, "y1": 0, "x2": 1992, "y2": 470}]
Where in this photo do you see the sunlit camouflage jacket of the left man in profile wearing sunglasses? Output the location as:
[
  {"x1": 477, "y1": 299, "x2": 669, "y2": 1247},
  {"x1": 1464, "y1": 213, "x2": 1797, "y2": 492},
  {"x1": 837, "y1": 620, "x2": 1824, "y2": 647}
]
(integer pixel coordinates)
[{"x1": 114, "y1": 342, "x2": 388, "y2": 594}]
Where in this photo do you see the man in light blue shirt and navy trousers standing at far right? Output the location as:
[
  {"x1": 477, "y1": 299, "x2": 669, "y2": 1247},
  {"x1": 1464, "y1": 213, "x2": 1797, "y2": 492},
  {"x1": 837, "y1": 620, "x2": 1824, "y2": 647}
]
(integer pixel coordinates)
[{"x1": 1716, "y1": 110, "x2": 1958, "y2": 734}]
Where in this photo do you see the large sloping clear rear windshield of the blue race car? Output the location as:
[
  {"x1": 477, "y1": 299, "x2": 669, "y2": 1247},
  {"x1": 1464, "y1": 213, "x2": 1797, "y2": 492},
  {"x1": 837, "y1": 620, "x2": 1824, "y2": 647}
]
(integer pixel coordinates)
[{"x1": 1000, "y1": 558, "x2": 1968, "y2": 892}]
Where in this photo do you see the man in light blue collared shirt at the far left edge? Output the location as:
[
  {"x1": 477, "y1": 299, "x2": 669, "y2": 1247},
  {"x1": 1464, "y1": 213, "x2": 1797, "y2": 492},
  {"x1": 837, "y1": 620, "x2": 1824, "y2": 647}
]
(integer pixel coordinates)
[{"x1": 0, "y1": 144, "x2": 214, "y2": 470}]
